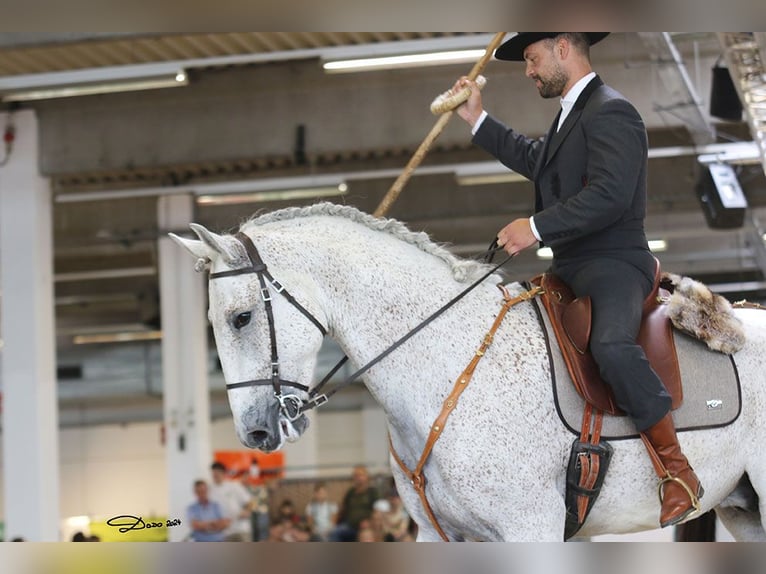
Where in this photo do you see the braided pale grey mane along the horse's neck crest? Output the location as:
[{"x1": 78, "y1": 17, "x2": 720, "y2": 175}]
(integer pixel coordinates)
[{"x1": 240, "y1": 201, "x2": 489, "y2": 283}]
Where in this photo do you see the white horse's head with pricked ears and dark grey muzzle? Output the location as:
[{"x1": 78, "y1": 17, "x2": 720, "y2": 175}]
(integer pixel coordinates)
[{"x1": 171, "y1": 218, "x2": 327, "y2": 451}]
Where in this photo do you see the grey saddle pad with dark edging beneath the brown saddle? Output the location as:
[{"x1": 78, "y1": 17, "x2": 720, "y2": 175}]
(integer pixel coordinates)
[{"x1": 534, "y1": 301, "x2": 742, "y2": 440}]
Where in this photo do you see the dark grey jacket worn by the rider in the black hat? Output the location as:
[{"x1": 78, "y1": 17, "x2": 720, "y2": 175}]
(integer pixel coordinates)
[{"x1": 473, "y1": 76, "x2": 651, "y2": 272}]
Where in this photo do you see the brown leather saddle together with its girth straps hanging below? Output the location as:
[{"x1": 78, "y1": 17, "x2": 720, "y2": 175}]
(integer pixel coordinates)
[{"x1": 531, "y1": 259, "x2": 683, "y2": 540}]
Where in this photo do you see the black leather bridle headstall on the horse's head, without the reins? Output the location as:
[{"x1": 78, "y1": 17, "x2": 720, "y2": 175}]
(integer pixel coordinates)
[{"x1": 210, "y1": 232, "x2": 327, "y2": 421}]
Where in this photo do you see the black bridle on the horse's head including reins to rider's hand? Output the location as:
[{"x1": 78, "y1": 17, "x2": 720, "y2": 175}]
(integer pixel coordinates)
[{"x1": 209, "y1": 231, "x2": 513, "y2": 421}]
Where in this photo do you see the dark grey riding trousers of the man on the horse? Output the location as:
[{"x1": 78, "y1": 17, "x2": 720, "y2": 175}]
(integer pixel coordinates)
[{"x1": 551, "y1": 252, "x2": 671, "y2": 432}]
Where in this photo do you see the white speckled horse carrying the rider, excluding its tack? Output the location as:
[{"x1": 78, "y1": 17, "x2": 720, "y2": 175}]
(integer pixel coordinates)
[{"x1": 172, "y1": 204, "x2": 766, "y2": 541}]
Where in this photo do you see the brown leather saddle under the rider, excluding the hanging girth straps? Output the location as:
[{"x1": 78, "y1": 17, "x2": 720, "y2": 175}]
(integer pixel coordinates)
[{"x1": 531, "y1": 259, "x2": 683, "y2": 415}]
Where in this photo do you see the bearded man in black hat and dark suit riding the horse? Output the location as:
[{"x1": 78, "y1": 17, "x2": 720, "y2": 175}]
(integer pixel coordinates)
[{"x1": 453, "y1": 32, "x2": 703, "y2": 527}]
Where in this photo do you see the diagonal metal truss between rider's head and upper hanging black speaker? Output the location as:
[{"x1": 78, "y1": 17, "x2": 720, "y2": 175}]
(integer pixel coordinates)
[{"x1": 638, "y1": 32, "x2": 716, "y2": 145}]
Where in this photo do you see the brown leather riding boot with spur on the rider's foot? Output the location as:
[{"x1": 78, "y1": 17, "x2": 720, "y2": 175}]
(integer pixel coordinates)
[{"x1": 641, "y1": 413, "x2": 705, "y2": 528}]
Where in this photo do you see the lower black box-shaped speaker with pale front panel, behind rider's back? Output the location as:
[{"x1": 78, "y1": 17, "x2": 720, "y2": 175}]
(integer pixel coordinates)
[{"x1": 695, "y1": 163, "x2": 747, "y2": 229}]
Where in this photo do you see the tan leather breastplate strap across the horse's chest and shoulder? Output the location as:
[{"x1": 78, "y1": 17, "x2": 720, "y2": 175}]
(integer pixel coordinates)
[{"x1": 388, "y1": 285, "x2": 542, "y2": 542}]
